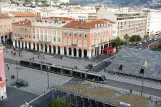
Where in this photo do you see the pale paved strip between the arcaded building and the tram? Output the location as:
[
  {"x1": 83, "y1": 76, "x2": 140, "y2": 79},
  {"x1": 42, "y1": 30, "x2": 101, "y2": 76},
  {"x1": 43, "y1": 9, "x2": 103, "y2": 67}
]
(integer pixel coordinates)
[{"x1": 4, "y1": 49, "x2": 97, "y2": 70}]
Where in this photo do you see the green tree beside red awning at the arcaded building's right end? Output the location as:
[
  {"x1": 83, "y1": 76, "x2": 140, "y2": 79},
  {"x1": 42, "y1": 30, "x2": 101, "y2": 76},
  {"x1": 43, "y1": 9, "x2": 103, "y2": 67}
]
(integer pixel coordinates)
[{"x1": 111, "y1": 37, "x2": 124, "y2": 51}]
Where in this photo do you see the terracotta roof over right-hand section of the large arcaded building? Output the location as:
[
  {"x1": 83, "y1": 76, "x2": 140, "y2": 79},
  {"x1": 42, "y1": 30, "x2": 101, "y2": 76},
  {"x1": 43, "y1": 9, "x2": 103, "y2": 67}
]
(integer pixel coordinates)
[{"x1": 64, "y1": 19, "x2": 112, "y2": 29}]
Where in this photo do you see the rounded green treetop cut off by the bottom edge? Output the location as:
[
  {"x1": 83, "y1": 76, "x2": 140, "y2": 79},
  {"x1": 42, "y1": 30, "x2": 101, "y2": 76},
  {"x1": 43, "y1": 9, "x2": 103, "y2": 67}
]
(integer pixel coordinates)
[{"x1": 46, "y1": 100, "x2": 70, "y2": 107}]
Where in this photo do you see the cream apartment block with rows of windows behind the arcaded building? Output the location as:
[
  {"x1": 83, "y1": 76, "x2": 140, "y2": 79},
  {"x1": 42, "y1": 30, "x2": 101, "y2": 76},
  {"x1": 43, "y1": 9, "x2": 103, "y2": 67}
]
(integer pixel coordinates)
[{"x1": 104, "y1": 12, "x2": 147, "y2": 39}]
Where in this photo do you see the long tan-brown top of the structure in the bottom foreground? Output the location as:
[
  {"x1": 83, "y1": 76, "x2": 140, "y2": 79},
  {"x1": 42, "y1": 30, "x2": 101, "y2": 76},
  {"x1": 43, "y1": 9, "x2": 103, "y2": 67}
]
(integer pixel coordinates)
[{"x1": 57, "y1": 84, "x2": 149, "y2": 107}]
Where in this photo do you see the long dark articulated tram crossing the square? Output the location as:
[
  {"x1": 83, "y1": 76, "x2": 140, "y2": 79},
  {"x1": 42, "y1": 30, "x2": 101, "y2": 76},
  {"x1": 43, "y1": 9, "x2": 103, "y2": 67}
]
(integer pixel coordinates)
[{"x1": 20, "y1": 60, "x2": 106, "y2": 83}]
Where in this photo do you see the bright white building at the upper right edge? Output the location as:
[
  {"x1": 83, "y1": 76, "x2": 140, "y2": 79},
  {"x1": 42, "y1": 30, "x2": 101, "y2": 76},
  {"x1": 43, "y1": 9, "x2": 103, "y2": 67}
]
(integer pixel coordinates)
[{"x1": 146, "y1": 11, "x2": 161, "y2": 37}]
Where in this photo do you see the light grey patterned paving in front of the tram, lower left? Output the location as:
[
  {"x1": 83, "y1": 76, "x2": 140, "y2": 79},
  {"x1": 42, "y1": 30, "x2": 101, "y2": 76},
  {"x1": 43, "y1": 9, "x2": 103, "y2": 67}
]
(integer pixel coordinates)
[{"x1": 5, "y1": 63, "x2": 72, "y2": 95}]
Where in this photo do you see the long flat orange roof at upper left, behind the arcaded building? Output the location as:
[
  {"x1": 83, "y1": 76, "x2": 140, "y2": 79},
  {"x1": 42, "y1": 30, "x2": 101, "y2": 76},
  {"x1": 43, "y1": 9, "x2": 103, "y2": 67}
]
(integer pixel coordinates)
[{"x1": 11, "y1": 12, "x2": 35, "y2": 17}]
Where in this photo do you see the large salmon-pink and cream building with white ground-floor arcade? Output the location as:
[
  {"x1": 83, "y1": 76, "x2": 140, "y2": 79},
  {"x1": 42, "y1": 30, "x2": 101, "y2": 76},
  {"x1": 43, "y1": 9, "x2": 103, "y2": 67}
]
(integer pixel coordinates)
[{"x1": 12, "y1": 17, "x2": 114, "y2": 58}]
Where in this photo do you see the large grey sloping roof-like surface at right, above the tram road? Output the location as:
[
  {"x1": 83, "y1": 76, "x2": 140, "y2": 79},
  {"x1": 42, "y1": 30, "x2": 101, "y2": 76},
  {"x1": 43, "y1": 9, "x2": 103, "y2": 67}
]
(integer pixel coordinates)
[{"x1": 108, "y1": 47, "x2": 161, "y2": 80}]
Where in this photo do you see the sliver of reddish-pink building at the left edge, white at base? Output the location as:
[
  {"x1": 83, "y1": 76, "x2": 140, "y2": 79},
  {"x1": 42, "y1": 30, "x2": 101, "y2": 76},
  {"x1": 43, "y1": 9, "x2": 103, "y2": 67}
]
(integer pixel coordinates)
[{"x1": 0, "y1": 47, "x2": 7, "y2": 100}]
